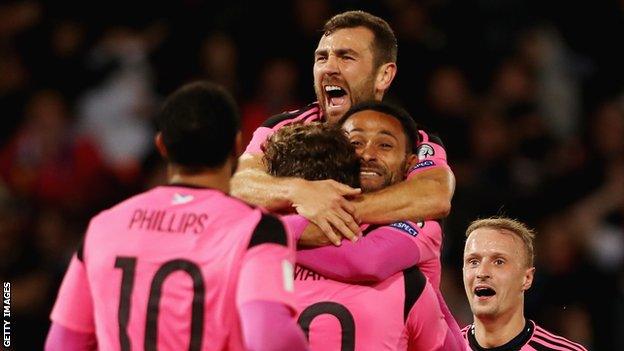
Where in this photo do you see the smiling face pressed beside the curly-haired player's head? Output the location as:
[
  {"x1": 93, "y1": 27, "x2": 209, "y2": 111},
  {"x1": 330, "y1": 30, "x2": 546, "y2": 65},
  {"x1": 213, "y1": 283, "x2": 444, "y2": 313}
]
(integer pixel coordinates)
[{"x1": 342, "y1": 110, "x2": 416, "y2": 191}]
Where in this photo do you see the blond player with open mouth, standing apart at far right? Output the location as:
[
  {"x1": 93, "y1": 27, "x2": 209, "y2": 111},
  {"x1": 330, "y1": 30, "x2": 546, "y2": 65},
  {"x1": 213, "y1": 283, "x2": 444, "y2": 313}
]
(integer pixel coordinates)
[{"x1": 462, "y1": 217, "x2": 587, "y2": 351}]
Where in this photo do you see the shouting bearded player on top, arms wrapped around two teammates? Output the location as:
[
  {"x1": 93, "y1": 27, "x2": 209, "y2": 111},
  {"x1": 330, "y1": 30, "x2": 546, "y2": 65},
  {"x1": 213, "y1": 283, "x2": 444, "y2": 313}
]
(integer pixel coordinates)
[{"x1": 232, "y1": 11, "x2": 454, "y2": 245}]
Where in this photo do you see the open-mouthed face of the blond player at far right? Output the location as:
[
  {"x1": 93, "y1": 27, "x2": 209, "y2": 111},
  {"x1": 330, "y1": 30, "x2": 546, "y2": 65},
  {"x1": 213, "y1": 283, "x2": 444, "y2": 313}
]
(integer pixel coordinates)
[{"x1": 463, "y1": 228, "x2": 535, "y2": 319}]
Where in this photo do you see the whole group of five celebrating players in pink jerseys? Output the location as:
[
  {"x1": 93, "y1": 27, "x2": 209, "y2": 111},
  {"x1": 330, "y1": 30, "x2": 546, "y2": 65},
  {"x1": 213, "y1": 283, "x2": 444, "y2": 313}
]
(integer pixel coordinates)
[{"x1": 46, "y1": 11, "x2": 586, "y2": 351}]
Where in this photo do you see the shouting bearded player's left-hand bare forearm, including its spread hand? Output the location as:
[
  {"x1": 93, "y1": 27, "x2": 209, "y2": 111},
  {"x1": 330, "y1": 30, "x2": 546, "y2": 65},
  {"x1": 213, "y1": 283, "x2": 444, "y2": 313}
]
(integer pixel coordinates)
[{"x1": 230, "y1": 153, "x2": 360, "y2": 242}]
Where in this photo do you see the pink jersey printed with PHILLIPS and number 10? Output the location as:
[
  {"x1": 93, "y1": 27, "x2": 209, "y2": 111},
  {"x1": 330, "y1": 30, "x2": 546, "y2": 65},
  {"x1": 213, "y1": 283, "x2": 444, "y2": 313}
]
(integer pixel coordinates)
[{"x1": 51, "y1": 185, "x2": 295, "y2": 350}]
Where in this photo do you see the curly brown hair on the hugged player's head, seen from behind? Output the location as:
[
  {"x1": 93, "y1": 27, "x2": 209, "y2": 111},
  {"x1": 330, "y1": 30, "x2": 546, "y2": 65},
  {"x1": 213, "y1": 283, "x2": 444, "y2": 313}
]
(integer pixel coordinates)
[{"x1": 263, "y1": 123, "x2": 360, "y2": 188}]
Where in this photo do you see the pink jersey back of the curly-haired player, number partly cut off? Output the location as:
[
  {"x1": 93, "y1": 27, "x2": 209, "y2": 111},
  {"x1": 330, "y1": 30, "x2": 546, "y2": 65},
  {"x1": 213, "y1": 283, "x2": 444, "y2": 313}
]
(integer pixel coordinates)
[{"x1": 295, "y1": 265, "x2": 449, "y2": 351}]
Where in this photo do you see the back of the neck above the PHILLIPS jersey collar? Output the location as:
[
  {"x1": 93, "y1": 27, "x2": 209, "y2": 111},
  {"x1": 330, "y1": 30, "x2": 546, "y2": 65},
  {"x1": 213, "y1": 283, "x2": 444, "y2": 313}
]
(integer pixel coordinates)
[{"x1": 167, "y1": 161, "x2": 232, "y2": 194}]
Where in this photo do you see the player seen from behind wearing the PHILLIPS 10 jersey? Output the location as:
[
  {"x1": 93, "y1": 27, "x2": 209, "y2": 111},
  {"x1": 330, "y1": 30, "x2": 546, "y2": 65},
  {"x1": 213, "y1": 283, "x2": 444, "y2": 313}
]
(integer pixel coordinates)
[{"x1": 46, "y1": 82, "x2": 307, "y2": 351}]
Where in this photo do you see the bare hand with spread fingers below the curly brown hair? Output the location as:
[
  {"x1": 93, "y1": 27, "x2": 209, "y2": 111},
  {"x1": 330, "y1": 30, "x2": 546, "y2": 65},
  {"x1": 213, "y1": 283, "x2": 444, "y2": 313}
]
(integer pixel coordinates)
[{"x1": 291, "y1": 180, "x2": 361, "y2": 246}]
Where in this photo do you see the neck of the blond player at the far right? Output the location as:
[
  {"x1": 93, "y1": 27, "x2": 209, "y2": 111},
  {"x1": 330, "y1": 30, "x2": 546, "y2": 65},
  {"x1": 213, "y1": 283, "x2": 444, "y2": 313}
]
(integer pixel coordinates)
[{"x1": 474, "y1": 308, "x2": 526, "y2": 348}]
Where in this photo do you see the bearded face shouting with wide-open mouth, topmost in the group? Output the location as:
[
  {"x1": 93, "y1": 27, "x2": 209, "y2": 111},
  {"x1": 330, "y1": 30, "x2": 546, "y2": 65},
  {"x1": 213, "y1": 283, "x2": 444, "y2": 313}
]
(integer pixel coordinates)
[{"x1": 314, "y1": 27, "x2": 376, "y2": 123}]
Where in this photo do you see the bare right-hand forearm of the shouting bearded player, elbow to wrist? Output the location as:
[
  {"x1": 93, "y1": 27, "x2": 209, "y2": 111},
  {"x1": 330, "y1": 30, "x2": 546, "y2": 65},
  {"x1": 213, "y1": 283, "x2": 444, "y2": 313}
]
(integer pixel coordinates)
[{"x1": 353, "y1": 167, "x2": 455, "y2": 223}]
